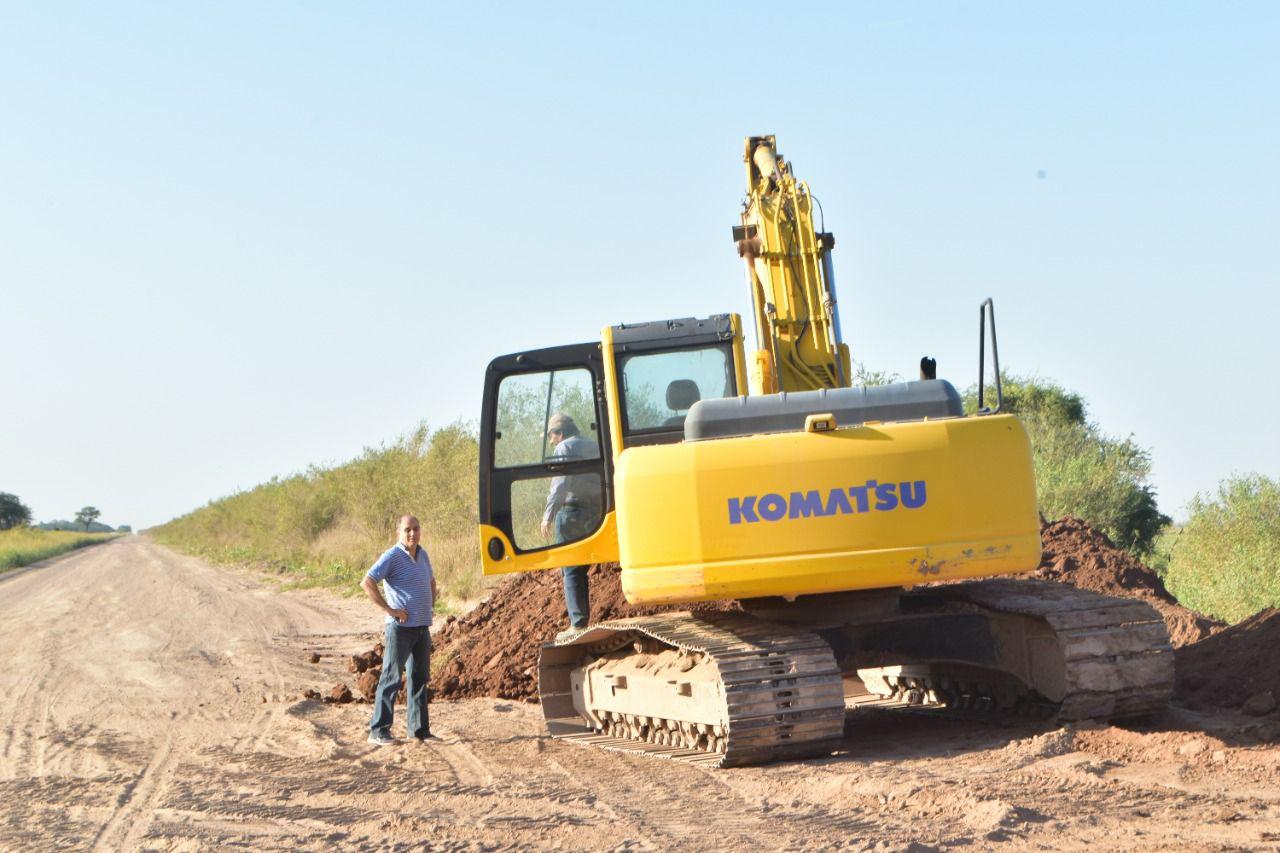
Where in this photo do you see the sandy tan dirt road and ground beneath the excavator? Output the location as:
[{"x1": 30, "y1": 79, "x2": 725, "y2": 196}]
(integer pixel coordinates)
[{"x1": 0, "y1": 537, "x2": 1280, "y2": 850}]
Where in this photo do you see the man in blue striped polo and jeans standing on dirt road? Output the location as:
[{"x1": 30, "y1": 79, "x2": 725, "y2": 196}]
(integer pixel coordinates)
[{"x1": 360, "y1": 515, "x2": 439, "y2": 745}]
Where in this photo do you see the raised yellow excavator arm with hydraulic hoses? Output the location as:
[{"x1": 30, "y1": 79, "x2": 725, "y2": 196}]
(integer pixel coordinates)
[{"x1": 733, "y1": 136, "x2": 850, "y2": 394}]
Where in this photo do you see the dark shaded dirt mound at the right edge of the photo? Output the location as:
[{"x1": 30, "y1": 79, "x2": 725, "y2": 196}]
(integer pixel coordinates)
[{"x1": 1176, "y1": 607, "x2": 1280, "y2": 708}]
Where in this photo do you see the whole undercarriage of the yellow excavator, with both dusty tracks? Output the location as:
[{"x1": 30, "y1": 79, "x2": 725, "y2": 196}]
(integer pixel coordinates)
[{"x1": 539, "y1": 579, "x2": 1174, "y2": 767}]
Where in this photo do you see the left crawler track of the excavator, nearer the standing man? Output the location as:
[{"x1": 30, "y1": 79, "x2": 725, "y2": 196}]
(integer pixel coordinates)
[{"x1": 539, "y1": 612, "x2": 845, "y2": 767}]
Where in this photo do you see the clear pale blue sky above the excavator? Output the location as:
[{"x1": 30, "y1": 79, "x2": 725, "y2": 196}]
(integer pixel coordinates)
[{"x1": 0, "y1": 3, "x2": 1280, "y2": 528}]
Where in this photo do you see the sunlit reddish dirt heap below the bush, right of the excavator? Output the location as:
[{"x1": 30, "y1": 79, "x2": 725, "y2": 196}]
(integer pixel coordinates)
[{"x1": 1032, "y1": 516, "x2": 1224, "y2": 648}]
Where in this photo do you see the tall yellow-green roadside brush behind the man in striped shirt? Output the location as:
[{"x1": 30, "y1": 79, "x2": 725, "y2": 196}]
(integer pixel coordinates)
[{"x1": 148, "y1": 424, "x2": 485, "y2": 612}]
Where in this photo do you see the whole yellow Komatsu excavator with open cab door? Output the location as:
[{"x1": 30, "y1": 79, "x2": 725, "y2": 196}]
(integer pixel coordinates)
[{"x1": 480, "y1": 136, "x2": 1174, "y2": 767}]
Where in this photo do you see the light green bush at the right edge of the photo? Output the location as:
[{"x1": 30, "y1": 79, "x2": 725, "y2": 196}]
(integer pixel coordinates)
[{"x1": 1166, "y1": 474, "x2": 1280, "y2": 622}]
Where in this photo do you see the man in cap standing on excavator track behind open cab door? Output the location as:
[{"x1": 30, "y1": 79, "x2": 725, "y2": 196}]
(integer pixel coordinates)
[{"x1": 541, "y1": 412, "x2": 602, "y2": 630}]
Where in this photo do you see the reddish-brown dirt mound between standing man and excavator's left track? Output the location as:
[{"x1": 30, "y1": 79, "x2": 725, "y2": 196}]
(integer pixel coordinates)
[{"x1": 431, "y1": 564, "x2": 740, "y2": 701}]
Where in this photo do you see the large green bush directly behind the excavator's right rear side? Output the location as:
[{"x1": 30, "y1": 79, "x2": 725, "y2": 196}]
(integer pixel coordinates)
[{"x1": 965, "y1": 377, "x2": 1170, "y2": 556}]
